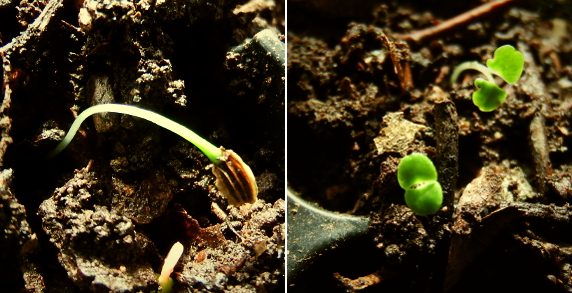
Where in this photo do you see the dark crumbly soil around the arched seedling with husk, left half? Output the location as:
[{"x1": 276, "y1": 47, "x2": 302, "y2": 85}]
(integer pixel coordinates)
[{"x1": 0, "y1": 0, "x2": 285, "y2": 292}]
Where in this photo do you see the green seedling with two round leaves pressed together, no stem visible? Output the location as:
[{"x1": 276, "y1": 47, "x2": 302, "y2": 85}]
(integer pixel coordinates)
[{"x1": 397, "y1": 153, "x2": 443, "y2": 216}]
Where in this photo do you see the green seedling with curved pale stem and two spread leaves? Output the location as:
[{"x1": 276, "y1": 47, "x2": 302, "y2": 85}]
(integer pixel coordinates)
[{"x1": 451, "y1": 45, "x2": 524, "y2": 112}]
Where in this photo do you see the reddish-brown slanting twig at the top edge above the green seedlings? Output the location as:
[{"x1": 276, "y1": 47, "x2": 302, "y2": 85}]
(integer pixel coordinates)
[{"x1": 397, "y1": 0, "x2": 516, "y2": 42}]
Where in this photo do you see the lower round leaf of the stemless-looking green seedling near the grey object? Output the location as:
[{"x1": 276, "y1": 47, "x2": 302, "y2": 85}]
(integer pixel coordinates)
[{"x1": 405, "y1": 181, "x2": 443, "y2": 216}]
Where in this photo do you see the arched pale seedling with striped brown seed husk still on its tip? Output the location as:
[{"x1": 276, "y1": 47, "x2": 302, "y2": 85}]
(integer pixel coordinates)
[{"x1": 46, "y1": 104, "x2": 258, "y2": 206}]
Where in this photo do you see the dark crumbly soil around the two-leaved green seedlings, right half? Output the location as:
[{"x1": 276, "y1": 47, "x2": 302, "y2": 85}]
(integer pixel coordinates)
[{"x1": 287, "y1": 0, "x2": 572, "y2": 292}]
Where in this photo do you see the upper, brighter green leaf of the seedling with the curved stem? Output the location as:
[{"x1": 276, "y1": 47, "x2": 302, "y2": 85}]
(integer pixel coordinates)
[{"x1": 487, "y1": 45, "x2": 524, "y2": 84}]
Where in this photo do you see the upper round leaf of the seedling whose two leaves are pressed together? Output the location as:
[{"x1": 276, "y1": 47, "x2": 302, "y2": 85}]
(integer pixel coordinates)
[{"x1": 397, "y1": 153, "x2": 437, "y2": 189}]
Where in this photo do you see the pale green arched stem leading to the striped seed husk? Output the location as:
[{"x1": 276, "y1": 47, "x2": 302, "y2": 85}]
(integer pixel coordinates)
[{"x1": 46, "y1": 104, "x2": 222, "y2": 164}]
